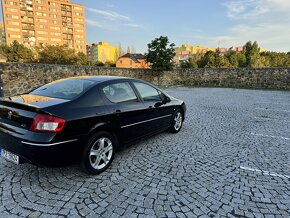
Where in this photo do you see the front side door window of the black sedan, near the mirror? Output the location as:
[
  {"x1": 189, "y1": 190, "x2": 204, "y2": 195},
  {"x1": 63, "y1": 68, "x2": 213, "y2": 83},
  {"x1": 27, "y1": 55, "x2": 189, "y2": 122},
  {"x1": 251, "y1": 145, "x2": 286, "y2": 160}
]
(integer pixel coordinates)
[{"x1": 134, "y1": 82, "x2": 162, "y2": 101}]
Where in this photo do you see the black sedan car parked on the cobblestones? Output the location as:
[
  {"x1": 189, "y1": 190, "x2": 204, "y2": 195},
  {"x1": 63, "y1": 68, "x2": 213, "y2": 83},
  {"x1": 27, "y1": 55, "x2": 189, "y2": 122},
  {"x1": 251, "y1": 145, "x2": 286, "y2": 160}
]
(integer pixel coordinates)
[{"x1": 0, "y1": 76, "x2": 186, "y2": 174}]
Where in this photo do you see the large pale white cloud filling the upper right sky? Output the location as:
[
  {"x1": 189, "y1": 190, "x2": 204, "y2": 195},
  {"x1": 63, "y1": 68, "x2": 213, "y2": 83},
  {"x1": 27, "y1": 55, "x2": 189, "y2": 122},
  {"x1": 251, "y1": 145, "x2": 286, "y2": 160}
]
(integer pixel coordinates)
[{"x1": 208, "y1": 0, "x2": 290, "y2": 51}]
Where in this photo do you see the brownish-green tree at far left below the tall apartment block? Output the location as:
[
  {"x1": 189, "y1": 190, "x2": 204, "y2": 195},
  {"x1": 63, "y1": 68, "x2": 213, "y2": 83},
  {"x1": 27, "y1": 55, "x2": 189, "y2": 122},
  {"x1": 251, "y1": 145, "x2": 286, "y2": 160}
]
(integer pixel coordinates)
[{"x1": 0, "y1": 41, "x2": 35, "y2": 63}]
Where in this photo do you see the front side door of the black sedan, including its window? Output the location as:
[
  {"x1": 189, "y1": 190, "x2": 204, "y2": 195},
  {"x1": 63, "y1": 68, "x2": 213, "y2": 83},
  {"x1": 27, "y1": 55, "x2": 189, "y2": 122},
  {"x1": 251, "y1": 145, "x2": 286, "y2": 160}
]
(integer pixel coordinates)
[{"x1": 133, "y1": 81, "x2": 174, "y2": 132}]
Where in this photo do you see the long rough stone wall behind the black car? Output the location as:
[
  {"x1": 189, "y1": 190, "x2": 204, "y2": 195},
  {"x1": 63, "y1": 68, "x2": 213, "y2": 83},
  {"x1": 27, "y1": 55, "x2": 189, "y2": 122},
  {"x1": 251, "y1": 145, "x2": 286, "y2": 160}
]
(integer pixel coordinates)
[{"x1": 0, "y1": 63, "x2": 290, "y2": 96}]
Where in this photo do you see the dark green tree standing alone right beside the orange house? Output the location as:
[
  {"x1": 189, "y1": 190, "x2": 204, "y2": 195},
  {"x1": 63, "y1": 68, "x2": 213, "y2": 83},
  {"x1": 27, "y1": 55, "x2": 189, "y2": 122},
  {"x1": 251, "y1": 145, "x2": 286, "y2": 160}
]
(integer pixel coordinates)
[{"x1": 146, "y1": 36, "x2": 175, "y2": 71}]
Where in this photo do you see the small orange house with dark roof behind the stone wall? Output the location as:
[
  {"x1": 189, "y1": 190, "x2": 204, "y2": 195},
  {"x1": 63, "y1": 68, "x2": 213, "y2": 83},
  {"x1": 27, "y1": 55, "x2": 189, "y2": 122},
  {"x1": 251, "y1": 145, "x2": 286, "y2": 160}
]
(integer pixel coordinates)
[{"x1": 116, "y1": 53, "x2": 149, "y2": 69}]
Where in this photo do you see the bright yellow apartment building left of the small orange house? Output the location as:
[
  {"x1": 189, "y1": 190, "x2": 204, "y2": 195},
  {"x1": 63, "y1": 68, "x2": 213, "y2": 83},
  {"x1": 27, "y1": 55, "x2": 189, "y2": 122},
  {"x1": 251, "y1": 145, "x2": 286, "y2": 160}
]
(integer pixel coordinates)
[{"x1": 86, "y1": 42, "x2": 120, "y2": 63}]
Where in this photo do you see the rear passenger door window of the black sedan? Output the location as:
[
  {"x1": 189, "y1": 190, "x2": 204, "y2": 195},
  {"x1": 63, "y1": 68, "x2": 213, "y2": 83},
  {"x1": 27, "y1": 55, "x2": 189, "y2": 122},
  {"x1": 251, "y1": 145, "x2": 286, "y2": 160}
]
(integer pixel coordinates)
[{"x1": 102, "y1": 82, "x2": 138, "y2": 103}]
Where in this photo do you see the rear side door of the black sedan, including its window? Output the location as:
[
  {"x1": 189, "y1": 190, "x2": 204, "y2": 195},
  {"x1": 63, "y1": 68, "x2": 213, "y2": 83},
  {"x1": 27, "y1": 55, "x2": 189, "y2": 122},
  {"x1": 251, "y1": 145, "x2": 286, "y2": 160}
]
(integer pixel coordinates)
[{"x1": 100, "y1": 81, "x2": 150, "y2": 143}]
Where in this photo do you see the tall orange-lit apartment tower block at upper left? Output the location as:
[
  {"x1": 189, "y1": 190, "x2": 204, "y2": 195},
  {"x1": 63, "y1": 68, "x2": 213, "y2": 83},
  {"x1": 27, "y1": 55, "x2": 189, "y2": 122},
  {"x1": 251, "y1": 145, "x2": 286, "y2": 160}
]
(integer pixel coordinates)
[{"x1": 2, "y1": 0, "x2": 86, "y2": 53}]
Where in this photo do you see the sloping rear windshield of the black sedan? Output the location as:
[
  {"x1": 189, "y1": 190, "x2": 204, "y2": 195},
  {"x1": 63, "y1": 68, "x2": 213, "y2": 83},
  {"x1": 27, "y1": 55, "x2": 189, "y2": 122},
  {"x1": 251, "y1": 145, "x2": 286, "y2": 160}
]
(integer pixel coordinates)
[{"x1": 30, "y1": 79, "x2": 95, "y2": 100}]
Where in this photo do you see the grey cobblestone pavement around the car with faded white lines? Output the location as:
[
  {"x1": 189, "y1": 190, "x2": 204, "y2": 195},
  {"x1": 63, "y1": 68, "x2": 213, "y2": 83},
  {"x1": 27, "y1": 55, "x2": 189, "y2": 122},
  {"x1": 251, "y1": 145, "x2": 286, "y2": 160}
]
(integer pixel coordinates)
[{"x1": 0, "y1": 88, "x2": 290, "y2": 218}]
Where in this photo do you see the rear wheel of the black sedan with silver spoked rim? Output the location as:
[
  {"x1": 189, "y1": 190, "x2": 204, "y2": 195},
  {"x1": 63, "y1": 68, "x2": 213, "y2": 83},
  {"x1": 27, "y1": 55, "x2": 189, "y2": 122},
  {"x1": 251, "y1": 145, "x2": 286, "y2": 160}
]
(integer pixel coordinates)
[{"x1": 81, "y1": 131, "x2": 118, "y2": 175}]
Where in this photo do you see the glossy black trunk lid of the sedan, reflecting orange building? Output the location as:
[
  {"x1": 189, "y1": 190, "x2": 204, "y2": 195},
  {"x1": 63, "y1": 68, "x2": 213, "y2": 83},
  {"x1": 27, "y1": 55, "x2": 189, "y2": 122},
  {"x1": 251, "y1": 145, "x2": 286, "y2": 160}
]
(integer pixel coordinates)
[{"x1": 1, "y1": 94, "x2": 70, "y2": 108}]
